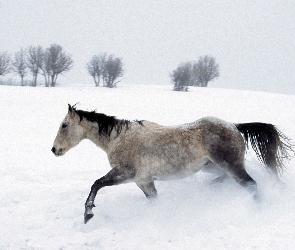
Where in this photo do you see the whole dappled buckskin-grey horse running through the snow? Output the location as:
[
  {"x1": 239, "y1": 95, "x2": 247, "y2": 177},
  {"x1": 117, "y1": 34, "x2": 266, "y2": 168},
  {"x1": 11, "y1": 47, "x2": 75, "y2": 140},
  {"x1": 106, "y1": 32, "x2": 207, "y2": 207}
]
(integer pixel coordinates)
[{"x1": 51, "y1": 104, "x2": 294, "y2": 224}]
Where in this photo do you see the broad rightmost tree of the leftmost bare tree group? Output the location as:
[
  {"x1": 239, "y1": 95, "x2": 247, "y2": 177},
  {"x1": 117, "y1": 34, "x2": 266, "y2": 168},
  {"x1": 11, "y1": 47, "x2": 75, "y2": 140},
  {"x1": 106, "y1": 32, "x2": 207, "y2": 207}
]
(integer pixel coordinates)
[{"x1": 40, "y1": 44, "x2": 73, "y2": 87}]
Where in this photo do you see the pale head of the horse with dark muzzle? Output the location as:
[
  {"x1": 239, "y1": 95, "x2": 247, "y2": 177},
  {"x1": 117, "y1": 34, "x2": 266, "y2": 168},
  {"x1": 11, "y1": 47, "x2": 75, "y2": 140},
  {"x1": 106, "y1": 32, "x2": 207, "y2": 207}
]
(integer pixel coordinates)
[{"x1": 51, "y1": 105, "x2": 84, "y2": 156}]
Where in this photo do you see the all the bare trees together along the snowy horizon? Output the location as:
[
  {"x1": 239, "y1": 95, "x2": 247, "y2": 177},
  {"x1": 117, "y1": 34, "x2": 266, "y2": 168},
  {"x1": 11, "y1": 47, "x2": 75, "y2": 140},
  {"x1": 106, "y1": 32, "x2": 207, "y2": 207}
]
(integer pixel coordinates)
[{"x1": 0, "y1": 44, "x2": 219, "y2": 91}]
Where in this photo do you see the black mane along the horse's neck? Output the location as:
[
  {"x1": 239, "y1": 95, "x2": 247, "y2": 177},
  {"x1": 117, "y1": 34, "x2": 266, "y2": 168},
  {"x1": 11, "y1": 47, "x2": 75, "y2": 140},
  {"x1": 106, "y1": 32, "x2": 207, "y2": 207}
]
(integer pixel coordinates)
[{"x1": 72, "y1": 107, "x2": 131, "y2": 136}]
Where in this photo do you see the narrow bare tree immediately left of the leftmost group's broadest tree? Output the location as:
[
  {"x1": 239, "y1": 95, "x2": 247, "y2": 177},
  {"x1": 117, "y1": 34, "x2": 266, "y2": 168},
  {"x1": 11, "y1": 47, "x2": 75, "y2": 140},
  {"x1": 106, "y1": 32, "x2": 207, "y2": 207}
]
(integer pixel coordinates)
[{"x1": 27, "y1": 46, "x2": 44, "y2": 87}]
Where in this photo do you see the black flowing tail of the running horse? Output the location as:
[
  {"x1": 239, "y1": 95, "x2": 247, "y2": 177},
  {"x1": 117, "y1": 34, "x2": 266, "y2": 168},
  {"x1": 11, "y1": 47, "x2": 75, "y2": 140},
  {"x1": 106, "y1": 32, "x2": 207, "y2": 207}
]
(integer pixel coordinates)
[{"x1": 235, "y1": 123, "x2": 294, "y2": 175}]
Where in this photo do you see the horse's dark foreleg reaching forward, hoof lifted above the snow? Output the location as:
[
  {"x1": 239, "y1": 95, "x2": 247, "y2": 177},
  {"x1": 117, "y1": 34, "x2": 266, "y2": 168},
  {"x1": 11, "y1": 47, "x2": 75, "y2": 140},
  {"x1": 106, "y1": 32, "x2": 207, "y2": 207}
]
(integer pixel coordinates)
[{"x1": 84, "y1": 166, "x2": 135, "y2": 224}]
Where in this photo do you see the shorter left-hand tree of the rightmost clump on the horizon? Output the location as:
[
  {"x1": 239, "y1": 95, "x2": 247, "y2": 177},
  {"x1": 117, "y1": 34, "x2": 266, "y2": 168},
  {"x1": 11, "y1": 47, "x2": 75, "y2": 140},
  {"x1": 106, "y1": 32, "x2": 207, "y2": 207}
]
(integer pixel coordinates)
[{"x1": 170, "y1": 62, "x2": 192, "y2": 91}]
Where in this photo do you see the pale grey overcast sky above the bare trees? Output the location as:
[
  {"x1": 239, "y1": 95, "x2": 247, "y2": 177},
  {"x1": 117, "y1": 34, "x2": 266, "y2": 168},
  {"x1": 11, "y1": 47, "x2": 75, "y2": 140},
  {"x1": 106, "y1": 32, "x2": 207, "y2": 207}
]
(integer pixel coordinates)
[{"x1": 0, "y1": 0, "x2": 295, "y2": 94}]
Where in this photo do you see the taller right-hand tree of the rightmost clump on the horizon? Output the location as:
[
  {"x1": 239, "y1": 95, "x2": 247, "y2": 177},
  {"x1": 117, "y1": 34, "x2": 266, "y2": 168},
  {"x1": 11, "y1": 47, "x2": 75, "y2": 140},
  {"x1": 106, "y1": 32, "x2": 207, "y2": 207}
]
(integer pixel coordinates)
[{"x1": 193, "y1": 55, "x2": 219, "y2": 87}]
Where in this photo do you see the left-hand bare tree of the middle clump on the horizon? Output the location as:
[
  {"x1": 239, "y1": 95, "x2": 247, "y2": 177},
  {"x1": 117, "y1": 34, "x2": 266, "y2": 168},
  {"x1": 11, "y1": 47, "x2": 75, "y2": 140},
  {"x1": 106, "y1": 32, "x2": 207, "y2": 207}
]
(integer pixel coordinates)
[{"x1": 86, "y1": 53, "x2": 107, "y2": 86}]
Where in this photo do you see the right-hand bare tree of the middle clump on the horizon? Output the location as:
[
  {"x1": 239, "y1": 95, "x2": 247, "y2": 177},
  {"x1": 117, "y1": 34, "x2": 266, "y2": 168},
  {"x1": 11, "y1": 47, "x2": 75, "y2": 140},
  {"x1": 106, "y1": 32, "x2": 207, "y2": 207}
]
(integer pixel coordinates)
[{"x1": 102, "y1": 55, "x2": 123, "y2": 88}]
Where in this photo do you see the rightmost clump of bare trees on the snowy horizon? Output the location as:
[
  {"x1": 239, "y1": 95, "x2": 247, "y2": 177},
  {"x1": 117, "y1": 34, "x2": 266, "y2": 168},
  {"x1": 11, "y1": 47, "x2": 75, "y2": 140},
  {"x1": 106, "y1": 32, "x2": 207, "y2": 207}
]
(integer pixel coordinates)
[{"x1": 170, "y1": 55, "x2": 219, "y2": 91}]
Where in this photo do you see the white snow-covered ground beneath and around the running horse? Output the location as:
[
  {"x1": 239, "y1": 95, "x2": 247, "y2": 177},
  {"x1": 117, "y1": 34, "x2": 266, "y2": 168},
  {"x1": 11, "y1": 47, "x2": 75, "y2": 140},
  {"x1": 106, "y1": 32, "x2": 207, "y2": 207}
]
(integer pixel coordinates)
[{"x1": 0, "y1": 85, "x2": 295, "y2": 250}]
